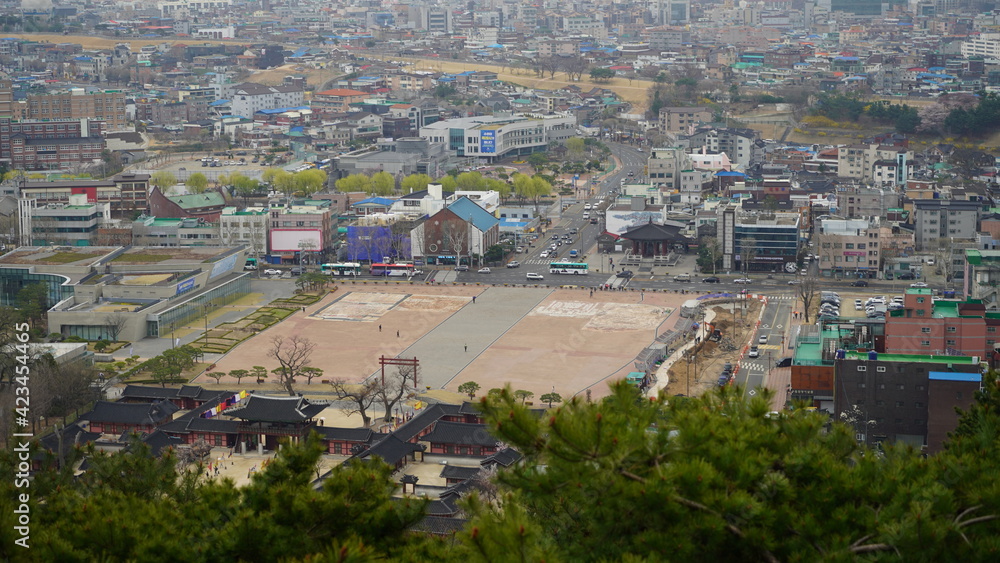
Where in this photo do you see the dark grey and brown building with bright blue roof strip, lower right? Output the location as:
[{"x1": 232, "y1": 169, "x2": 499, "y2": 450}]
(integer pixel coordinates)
[{"x1": 834, "y1": 352, "x2": 982, "y2": 454}]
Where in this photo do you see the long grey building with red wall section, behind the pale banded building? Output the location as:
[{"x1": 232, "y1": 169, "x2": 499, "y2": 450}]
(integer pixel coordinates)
[{"x1": 18, "y1": 173, "x2": 149, "y2": 217}]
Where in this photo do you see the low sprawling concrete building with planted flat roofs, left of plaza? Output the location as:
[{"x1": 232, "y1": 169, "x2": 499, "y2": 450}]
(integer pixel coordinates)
[{"x1": 0, "y1": 246, "x2": 250, "y2": 341}]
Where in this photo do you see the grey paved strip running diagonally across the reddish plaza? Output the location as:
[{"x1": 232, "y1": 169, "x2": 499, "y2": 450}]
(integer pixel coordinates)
[{"x1": 372, "y1": 287, "x2": 552, "y2": 389}]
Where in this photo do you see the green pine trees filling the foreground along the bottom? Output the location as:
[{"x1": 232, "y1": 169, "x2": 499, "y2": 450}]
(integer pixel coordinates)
[{"x1": 9, "y1": 373, "x2": 1000, "y2": 562}]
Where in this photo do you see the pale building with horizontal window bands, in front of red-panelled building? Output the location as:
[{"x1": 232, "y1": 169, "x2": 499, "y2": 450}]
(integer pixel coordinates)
[{"x1": 18, "y1": 194, "x2": 111, "y2": 246}]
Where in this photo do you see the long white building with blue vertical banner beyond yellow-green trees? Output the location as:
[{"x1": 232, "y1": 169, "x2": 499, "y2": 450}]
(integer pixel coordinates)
[{"x1": 420, "y1": 113, "x2": 576, "y2": 162}]
